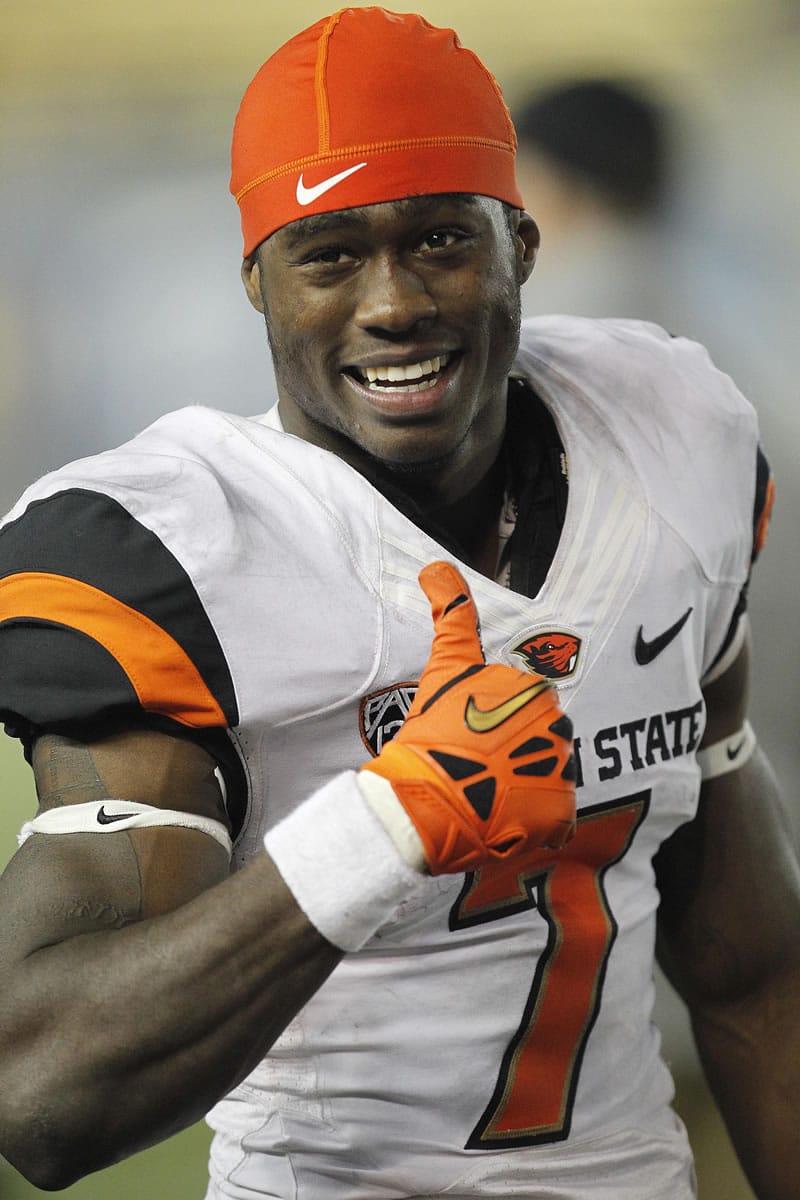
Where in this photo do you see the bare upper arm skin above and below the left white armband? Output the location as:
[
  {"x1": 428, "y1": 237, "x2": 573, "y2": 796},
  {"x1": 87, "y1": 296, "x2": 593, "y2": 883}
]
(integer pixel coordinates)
[{"x1": 0, "y1": 732, "x2": 228, "y2": 964}]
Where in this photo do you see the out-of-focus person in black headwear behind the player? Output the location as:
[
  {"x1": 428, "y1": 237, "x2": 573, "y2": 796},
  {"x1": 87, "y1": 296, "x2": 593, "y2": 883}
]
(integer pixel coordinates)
[{"x1": 513, "y1": 78, "x2": 682, "y2": 331}]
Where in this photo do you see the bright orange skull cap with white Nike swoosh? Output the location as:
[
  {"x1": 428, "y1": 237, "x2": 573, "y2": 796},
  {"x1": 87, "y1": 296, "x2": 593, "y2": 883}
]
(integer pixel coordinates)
[{"x1": 230, "y1": 7, "x2": 523, "y2": 256}]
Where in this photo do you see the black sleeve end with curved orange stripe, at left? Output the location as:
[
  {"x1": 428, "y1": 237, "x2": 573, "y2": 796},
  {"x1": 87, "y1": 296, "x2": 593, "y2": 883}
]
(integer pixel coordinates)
[{"x1": 0, "y1": 490, "x2": 239, "y2": 730}]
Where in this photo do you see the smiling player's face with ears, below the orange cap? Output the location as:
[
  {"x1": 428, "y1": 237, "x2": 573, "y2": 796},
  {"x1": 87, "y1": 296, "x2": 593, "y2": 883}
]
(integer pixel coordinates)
[{"x1": 243, "y1": 194, "x2": 527, "y2": 472}]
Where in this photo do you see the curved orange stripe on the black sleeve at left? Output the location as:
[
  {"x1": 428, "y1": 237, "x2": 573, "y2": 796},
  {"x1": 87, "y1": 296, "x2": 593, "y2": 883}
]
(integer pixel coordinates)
[{"x1": 0, "y1": 571, "x2": 227, "y2": 727}]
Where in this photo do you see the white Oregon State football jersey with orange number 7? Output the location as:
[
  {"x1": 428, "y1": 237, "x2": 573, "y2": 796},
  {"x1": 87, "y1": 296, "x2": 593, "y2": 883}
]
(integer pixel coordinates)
[{"x1": 0, "y1": 318, "x2": 757, "y2": 1200}]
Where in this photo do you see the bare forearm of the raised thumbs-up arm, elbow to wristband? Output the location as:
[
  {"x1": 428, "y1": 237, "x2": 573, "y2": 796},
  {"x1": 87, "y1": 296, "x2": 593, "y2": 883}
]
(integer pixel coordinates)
[{"x1": 0, "y1": 854, "x2": 341, "y2": 1187}]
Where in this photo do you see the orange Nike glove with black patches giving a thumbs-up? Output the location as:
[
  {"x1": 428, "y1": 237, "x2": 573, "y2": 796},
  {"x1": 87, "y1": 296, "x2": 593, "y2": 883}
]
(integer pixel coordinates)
[{"x1": 361, "y1": 562, "x2": 576, "y2": 875}]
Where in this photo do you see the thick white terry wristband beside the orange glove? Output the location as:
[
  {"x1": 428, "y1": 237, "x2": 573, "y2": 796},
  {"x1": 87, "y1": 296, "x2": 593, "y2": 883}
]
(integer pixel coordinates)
[{"x1": 264, "y1": 770, "x2": 420, "y2": 950}]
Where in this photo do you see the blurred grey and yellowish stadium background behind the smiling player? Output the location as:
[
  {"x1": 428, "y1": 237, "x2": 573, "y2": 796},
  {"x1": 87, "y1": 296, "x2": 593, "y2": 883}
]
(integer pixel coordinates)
[{"x1": 0, "y1": 0, "x2": 800, "y2": 1200}]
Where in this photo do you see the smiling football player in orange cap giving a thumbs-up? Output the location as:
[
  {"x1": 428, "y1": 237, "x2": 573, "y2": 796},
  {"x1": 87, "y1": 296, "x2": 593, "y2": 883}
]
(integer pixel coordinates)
[{"x1": 0, "y1": 8, "x2": 800, "y2": 1200}]
